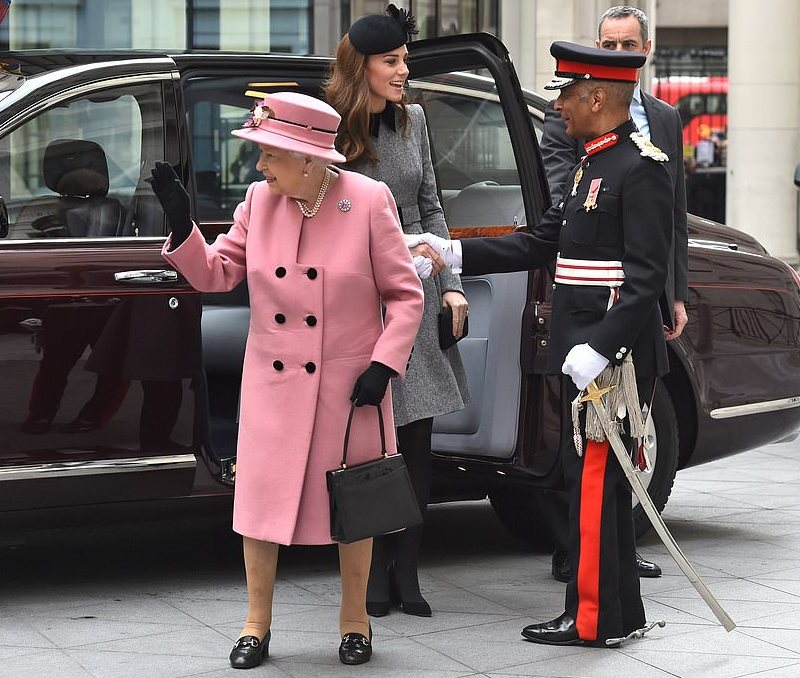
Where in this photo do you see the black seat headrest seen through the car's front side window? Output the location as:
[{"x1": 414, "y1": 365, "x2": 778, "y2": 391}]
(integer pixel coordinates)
[{"x1": 42, "y1": 139, "x2": 108, "y2": 198}]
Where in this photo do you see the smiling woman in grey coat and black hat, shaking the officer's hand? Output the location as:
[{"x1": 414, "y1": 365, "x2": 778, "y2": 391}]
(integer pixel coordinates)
[{"x1": 325, "y1": 5, "x2": 468, "y2": 617}]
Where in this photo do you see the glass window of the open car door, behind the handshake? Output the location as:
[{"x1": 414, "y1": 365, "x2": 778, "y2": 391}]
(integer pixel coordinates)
[{"x1": 410, "y1": 78, "x2": 527, "y2": 230}]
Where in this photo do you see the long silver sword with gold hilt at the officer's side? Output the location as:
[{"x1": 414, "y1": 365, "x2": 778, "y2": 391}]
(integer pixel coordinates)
[{"x1": 575, "y1": 382, "x2": 736, "y2": 632}]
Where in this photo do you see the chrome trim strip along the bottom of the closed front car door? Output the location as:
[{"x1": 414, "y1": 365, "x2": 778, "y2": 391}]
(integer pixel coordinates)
[{"x1": 0, "y1": 454, "x2": 197, "y2": 482}]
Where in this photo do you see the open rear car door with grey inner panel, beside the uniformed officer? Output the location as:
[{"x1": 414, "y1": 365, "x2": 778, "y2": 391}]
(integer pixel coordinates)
[{"x1": 409, "y1": 34, "x2": 558, "y2": 466}]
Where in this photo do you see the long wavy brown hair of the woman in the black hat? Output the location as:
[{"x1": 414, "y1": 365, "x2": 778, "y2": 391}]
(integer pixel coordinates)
[{"x1": 322, "y1": 34, "x2": 408, "y2": 163}]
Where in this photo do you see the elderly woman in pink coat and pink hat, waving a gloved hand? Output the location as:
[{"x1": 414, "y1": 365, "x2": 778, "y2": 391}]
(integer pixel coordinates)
[{"x1": 152, "y1": 92, "x2": 422, "y2": 668}]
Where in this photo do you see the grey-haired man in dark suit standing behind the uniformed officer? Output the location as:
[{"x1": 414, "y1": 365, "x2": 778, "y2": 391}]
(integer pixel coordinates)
[{"x1": 541, "y1": 6, "x2": 688, "y2": 582}]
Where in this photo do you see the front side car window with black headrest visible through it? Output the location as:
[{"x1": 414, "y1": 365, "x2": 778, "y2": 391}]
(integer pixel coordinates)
[{"x1": 0, "y1": 84, "x2": 164, "y2": 240}]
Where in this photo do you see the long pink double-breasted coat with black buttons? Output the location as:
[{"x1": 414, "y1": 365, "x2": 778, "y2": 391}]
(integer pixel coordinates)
[{"x1": 163, "y1": 170, "x2": 423, "y2": 544}]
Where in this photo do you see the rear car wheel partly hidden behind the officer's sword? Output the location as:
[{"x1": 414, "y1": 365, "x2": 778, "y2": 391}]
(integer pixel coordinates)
[{"x1": 633, "y1": 380, "x2": 680, "y2": 537}]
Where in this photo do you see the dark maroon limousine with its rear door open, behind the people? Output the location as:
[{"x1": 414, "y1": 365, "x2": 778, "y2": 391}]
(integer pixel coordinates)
[{"x1": 0, "y1": 35, "x2": 800, "y2": 540}]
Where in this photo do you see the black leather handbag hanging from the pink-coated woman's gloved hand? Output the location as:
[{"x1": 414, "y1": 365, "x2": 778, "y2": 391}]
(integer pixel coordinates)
[{"x1": 325, "y1": 405, "x2": 422, "y2": 544}]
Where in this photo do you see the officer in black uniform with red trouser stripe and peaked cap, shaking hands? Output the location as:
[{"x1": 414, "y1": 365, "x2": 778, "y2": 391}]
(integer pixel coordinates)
[{"x1": 424, "y1": 42, "x2": 673, "y2": 646}]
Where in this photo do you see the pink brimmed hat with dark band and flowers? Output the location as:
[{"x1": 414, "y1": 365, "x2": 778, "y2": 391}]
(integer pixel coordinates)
[{"x1": 231, "y1": 92, "x2": 346, "y2": 162}]
